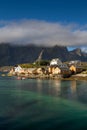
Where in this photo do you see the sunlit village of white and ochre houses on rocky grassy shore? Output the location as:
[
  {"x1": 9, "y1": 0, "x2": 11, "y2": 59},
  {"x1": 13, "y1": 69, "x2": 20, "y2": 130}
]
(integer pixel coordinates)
[{"x1": 8, "y1": 52, "x2": 87, "y2": 80}]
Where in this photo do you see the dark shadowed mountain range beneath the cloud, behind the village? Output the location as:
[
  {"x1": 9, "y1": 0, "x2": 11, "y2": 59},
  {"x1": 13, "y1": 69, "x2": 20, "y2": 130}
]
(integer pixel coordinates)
[{"x1": 0, "y1": 44, "x2": 87, "y2": 66}]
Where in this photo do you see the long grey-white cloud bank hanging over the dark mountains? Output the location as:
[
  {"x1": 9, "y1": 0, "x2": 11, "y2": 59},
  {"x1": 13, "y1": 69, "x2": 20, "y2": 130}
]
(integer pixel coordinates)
[{"x1": 0, "y1": 20, "x2": 87, "y2": 46}]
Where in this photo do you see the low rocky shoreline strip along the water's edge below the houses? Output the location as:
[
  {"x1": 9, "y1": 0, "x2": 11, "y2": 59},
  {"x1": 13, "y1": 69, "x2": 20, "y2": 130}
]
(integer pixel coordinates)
[{"x1": 0, "y1": 67, "x2": 87, "y2": 81}]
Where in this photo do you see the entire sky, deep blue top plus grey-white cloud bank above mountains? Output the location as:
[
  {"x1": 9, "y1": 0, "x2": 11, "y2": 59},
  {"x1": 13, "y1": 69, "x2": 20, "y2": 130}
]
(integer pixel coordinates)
[{"x1": 0, "y1": 0, "x2": 87, "y2": 52}]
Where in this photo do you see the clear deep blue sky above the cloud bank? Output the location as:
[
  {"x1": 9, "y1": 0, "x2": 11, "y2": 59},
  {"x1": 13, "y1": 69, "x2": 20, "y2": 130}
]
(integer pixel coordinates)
[{"x1": 0, "y1": 0, "x2": 87, "y2": 24}]
